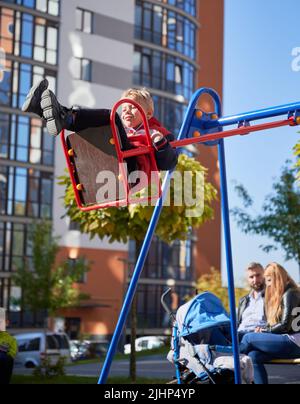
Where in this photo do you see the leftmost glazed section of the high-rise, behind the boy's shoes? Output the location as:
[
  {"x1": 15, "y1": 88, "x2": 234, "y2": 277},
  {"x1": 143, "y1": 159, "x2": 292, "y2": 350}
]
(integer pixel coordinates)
[{"x1": 0, "y1": 0, "x2": 60, "y2": 327}]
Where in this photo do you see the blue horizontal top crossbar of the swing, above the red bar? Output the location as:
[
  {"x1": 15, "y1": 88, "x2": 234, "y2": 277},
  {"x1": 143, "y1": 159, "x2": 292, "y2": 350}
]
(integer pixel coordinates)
[{"x1": 207, "y1": 102, "x2": 300, "y2": 127}]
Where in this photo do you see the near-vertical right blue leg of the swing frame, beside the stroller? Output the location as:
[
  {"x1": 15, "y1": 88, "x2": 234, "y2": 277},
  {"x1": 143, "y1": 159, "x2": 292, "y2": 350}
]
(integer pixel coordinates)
[{"x1": 218, "y1": 139, "x2": 242, "y2": 384}]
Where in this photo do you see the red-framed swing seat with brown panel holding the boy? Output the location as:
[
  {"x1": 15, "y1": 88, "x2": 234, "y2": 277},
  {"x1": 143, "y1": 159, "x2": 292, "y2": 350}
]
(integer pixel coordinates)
[{"x1": 61, "y1": 100, "x2": 161, "y2": 211}]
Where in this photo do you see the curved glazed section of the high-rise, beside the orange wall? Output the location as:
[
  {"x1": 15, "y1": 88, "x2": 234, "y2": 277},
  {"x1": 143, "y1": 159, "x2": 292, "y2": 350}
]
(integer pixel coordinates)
[{"x1": 132, "y1": 0, "x2": 200, "y2": 334}]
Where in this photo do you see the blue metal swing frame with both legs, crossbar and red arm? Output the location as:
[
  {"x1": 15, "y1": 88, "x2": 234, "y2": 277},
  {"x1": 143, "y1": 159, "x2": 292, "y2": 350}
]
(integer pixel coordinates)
[{"x1": 98, "y1": 88, "x2": 300, "y2": 384}]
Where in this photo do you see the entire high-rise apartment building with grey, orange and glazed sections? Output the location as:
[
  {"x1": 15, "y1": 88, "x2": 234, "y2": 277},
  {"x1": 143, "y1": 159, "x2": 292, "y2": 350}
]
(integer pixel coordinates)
[{"x1": 0, "y1": 0, "x2": 223, "y2": 339}]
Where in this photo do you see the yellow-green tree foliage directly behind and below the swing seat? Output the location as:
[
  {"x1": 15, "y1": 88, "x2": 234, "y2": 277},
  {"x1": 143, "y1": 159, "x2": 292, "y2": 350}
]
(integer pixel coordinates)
[{"x1": 60, "y1": 155, "x2": 217, "y2": 243}]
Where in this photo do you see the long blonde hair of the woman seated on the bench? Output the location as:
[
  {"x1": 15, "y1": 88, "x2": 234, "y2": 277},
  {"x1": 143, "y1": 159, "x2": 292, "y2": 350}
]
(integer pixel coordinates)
[{"x1": 265, "y1": 262, "x2": 298, "y2": 326}]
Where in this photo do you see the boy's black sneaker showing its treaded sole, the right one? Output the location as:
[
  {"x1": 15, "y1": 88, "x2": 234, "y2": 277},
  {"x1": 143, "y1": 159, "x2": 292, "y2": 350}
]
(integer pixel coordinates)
[{"x1": 41, "y1": 89, "x2": 73, "y2": 136}]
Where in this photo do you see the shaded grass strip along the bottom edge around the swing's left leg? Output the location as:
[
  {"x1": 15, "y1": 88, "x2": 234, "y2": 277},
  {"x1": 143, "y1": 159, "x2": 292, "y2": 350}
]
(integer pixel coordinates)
[{"x1": 11, "y1": 375, "x2": 167, "y2": 384}]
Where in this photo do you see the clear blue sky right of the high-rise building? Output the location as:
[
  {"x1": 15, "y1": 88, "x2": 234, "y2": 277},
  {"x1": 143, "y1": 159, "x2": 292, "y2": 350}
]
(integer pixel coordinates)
[{"x1": 222, "y1": 0, "x2": 300, "y2": 285}]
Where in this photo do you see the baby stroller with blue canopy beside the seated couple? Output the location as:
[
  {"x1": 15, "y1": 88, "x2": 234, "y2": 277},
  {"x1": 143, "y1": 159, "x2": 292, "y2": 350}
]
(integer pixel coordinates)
[{"x1": 161, "y1": 289, "x2": 253, "y2": 384}]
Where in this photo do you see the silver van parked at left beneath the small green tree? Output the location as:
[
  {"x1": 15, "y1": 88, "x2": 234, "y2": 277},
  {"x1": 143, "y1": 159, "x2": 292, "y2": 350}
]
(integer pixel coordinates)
[{"x1": 15, "y1": 332, "x2": 71, "y2": 368}]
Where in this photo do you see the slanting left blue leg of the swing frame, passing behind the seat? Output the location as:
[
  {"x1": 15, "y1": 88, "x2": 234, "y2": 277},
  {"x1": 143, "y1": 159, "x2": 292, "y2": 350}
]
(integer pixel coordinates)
[{"x1": 98, "y1": 89, "x2": 203, "y2": 384}]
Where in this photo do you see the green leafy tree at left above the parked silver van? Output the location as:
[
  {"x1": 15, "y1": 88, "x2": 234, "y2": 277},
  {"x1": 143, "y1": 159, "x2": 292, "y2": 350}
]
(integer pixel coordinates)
[{"x1": 13, "y1": 223, "x2": 89, "y2": 314}]
